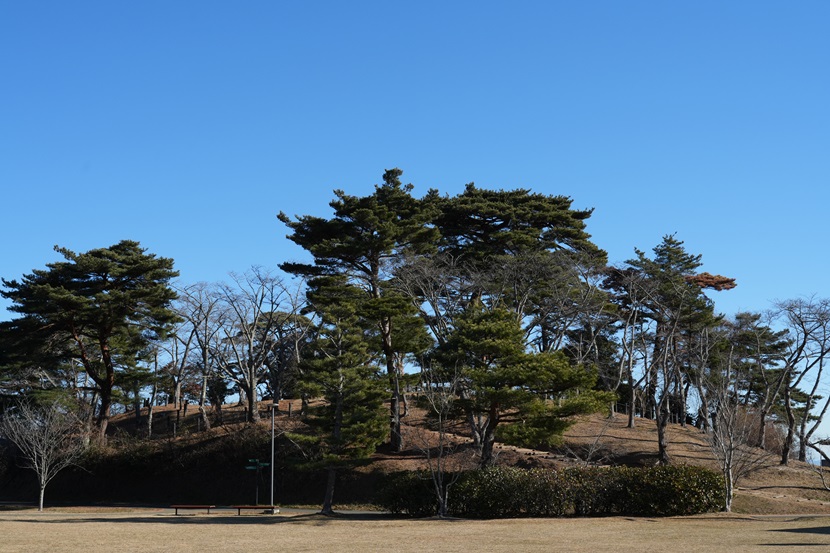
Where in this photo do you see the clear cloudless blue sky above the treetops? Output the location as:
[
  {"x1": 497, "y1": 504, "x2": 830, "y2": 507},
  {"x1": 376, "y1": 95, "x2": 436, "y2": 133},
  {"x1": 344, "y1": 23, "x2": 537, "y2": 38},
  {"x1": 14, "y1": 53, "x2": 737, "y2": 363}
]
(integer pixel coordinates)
[{"x1": 0, "y1": 0, "x2": 830, "y2": 318}]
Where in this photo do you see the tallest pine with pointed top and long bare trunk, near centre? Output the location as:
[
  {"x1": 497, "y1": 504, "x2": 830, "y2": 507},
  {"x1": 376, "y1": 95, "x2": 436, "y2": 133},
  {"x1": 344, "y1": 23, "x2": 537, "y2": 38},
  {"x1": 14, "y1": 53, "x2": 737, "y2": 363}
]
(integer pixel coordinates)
[{"x1": 279, "y1": 169, "x2": 438, "y2": 450}]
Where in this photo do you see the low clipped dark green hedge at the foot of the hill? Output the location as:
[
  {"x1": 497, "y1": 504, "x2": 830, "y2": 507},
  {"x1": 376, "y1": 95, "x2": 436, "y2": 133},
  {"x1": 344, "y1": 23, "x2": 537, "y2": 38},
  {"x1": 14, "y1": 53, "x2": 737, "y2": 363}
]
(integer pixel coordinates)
[{"x1": 378, "y1": 466, "x2": 724, "y2": 518}]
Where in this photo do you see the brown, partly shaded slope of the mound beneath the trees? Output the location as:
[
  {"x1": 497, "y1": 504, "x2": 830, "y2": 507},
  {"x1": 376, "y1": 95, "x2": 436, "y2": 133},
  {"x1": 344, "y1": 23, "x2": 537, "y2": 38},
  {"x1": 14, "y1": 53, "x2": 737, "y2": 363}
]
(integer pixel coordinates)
[{"x1": 14, "y1": 401, "x2": 830, "y2": 514}]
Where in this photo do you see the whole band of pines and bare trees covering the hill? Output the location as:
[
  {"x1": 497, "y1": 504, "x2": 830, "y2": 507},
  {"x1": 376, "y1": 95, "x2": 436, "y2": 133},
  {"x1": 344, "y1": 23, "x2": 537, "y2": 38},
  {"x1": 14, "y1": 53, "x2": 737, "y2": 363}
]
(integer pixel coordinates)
[{"x1": 0, "y1": 169, "x2": 830, "y2": 512}]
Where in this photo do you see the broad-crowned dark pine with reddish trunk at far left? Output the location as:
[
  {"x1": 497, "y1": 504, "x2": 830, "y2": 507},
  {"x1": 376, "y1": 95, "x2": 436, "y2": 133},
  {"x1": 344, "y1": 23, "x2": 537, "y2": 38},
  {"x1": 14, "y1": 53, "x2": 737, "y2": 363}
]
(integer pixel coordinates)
[{"x1": 0, "y1": 240, "x2": 178, "y2": 439}]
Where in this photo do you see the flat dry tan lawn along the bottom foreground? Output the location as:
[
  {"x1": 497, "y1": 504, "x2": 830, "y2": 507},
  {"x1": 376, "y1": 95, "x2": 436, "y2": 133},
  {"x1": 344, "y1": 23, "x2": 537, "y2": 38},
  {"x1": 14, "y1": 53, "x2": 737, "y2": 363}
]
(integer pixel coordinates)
[{"x1": 0, "y1": 510, "x2": 830, "y2": 553}]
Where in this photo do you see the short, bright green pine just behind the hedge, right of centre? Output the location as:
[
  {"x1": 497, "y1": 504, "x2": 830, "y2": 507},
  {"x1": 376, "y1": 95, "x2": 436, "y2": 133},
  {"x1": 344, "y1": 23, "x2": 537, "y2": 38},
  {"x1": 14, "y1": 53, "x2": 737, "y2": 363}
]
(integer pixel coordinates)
[{"x1": 435, "y1": 306, "x2": 613, "y2": 466}]
